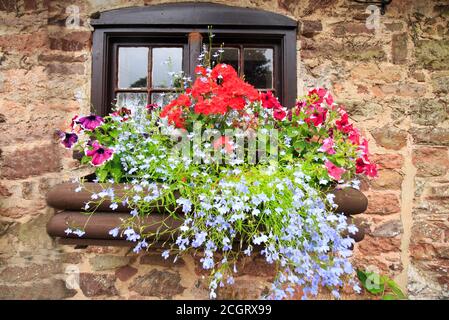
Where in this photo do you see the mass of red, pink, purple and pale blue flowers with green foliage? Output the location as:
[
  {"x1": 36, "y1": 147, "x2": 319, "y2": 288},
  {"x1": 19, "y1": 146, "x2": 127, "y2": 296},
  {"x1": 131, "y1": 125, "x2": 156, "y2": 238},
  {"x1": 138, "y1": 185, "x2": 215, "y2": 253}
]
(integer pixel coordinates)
[{"x1": 58, "y1": 38, "x2": 376, "y2": 299}]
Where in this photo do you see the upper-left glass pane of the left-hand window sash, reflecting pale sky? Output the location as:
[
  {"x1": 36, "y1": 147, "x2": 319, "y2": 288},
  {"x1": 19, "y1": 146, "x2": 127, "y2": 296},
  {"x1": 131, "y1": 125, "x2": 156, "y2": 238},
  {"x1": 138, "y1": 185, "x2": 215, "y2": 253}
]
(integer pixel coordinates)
[{"x1": 118, "y1": 47, "x2": 149, "y2": 89}]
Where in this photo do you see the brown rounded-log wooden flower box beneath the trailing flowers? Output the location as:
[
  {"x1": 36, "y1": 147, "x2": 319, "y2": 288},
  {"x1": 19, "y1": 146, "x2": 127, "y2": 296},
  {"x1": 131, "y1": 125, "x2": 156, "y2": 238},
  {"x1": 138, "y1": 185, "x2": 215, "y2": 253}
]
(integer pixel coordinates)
[{"x1": 47, "y1": 182, "x2": 368, "y2": 246}]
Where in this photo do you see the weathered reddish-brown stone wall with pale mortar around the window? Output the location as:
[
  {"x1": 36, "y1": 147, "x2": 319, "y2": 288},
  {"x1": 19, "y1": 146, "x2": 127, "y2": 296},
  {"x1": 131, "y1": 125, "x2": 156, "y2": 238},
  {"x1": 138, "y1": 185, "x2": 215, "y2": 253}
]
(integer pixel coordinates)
[{"x1": 0, "y1": 0, "x2": 449, "y2": 299}]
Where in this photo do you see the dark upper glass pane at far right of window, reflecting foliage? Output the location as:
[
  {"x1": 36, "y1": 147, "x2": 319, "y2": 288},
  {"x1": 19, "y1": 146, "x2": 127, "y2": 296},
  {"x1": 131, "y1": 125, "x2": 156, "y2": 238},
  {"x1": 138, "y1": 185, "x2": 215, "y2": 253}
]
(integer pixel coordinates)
[{"x1": 243, "y1": 48, "x2": 273, "y2": 89}]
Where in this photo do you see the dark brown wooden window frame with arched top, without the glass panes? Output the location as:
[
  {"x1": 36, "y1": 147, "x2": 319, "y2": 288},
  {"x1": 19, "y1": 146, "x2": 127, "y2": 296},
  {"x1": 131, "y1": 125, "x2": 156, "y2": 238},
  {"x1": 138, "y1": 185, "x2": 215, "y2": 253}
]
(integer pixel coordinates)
[{"x1": 91, "y1": 3, "x2": 297, "y2": 115}]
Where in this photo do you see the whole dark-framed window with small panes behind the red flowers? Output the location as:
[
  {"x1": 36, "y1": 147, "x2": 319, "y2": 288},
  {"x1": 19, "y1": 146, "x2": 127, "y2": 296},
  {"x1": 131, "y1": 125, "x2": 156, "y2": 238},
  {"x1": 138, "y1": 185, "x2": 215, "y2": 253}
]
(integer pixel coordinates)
[{"x1": 91, "y1": 3, "x2": 297, "y2": 115}]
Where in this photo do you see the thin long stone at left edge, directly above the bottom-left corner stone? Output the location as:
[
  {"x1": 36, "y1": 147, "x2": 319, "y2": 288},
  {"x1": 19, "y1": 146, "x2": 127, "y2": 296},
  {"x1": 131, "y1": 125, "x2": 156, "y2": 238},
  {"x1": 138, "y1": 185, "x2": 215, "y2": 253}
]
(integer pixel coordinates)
[{"x1": 0, "y1": 262, "x2": 63, "y2": 283}]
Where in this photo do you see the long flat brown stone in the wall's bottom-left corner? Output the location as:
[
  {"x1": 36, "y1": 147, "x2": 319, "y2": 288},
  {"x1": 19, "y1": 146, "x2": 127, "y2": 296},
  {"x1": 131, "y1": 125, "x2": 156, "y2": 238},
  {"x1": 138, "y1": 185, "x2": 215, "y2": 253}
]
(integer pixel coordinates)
[{"x1": 0, "y1": 279, "x2": 76, "y2": 300}]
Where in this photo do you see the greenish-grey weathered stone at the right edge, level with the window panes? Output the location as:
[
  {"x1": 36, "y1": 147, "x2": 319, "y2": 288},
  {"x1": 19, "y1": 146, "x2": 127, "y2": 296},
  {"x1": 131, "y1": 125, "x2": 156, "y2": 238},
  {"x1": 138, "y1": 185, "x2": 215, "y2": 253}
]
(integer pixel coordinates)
[{"x1": 415, "y1": 40, "x2": 449, "y2": 70}]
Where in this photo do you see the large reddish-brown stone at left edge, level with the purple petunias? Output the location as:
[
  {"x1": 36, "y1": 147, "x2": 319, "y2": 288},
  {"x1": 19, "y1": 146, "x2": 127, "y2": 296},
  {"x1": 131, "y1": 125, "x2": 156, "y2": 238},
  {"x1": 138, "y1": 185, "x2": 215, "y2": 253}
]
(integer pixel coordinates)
[{"x1": 1, "y1": 144, "x2": 61, "y2": 179}]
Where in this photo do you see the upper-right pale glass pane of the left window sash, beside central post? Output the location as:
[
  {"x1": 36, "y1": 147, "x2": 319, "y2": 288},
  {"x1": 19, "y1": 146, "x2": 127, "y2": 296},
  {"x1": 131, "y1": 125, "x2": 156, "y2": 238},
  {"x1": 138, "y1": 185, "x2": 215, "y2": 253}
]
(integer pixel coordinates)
[{"x1": 152, "y1": 48, "x2": 182, "y2": 88}]
